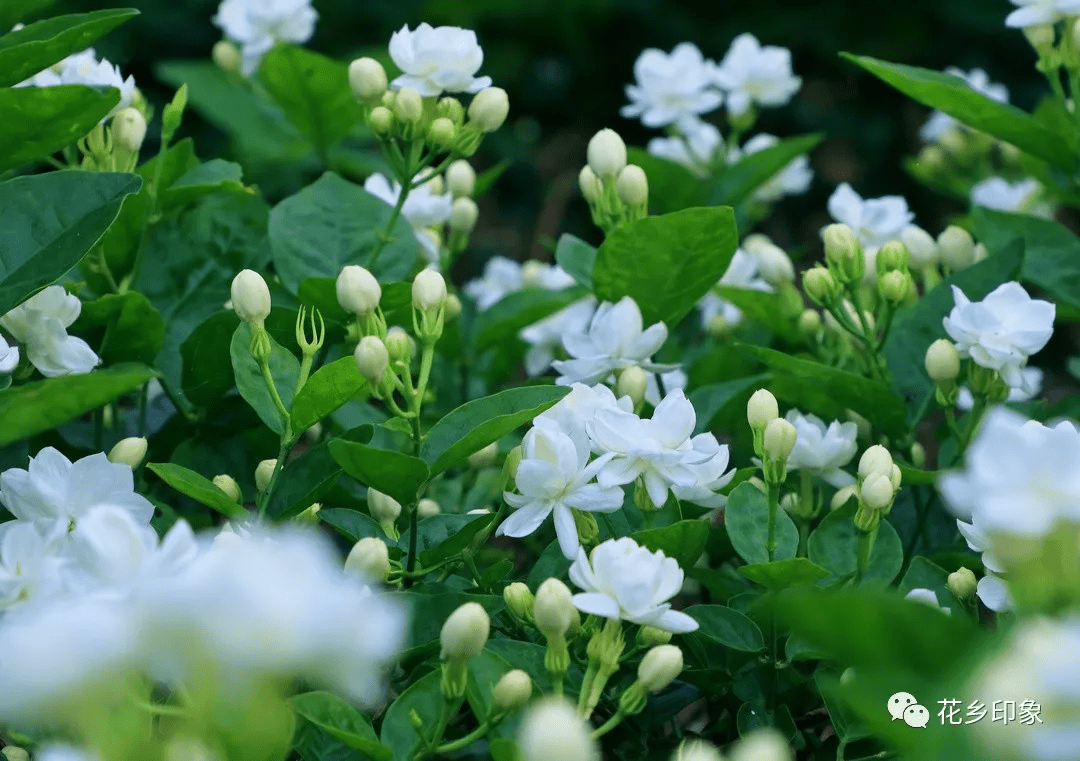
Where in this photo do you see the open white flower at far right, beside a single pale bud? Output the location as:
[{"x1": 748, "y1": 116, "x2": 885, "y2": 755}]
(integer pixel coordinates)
[{"x1": 943, "y1": 283, "x2": 1055, "y2": 386}]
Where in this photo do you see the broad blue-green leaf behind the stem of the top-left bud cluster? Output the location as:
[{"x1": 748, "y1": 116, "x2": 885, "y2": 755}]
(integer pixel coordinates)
[{"x1": 270, "y1": 172, "x2": 419, "y2": 294}]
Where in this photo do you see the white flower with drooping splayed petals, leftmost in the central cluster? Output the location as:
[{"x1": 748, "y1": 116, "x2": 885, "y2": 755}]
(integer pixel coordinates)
[{"x1": 496, "y1": 425, "x2": 623, "y2": 558}]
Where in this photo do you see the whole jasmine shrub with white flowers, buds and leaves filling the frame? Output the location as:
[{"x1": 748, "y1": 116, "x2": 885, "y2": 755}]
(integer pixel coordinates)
[{"x1": 0, "y1": 0, "x2": 1080, "y2": 761}]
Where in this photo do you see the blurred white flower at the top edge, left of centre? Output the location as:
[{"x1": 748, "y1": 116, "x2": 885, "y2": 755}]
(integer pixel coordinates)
[{"x1": 214, "y1": 0, "x2": 319, "y2": 77}]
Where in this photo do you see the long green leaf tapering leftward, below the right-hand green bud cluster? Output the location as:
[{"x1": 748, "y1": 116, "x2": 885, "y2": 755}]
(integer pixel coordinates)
[{"x1": 740, "y1": 344, "x2": 907, "y2": 436}]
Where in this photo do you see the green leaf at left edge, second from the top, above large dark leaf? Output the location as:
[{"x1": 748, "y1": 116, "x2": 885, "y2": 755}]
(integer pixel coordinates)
[{"x1": 0, "y1": 84, "x2": 120, "y2": 172}]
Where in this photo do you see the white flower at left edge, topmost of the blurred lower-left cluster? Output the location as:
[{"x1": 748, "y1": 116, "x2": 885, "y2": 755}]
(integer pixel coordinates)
[{"x1": 0, "y1": 447, "x2": 153, "y2": 533}]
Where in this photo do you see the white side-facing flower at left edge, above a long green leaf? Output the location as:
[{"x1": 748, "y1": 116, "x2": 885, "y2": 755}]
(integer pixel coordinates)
[{"x1": 0, "y1": 285, "x2": 100, "y2": 378}]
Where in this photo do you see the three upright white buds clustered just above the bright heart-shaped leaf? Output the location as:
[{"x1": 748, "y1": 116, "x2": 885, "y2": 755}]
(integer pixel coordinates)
[{"x1": 578, "y1": 130, "x2": 649, "y2": 232}]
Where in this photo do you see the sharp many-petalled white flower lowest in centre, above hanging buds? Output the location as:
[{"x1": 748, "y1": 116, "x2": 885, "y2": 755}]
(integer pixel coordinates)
[{"x1": 570, "y1": 538, "x2": 698, "y2": 634}]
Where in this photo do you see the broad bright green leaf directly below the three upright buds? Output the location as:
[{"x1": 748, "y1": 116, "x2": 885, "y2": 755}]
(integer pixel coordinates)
[{"x1": 593, "y1": 207, "x2": 739, "y2": 327}]
